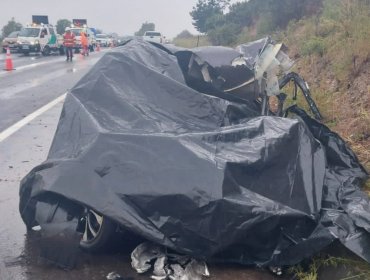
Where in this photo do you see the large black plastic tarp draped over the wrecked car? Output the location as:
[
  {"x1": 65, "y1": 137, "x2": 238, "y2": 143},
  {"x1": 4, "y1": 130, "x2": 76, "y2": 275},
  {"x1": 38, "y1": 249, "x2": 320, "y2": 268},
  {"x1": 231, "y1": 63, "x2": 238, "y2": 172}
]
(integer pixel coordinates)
[{"x1": 20, "y1": 38, "x2": 370, "y2": 266}]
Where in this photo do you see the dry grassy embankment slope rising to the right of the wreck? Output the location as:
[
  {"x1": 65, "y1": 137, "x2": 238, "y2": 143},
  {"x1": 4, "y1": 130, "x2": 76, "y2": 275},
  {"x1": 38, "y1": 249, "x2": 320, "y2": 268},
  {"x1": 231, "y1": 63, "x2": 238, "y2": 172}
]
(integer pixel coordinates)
[{"x1": 275, "y1": 0, "x2": 370, "y2": 179}]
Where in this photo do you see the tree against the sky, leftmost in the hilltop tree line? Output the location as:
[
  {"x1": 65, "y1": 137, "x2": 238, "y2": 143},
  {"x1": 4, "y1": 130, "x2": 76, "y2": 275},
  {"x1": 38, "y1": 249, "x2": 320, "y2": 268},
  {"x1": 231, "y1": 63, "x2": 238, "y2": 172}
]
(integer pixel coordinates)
[{"x1": 190, "y1": 0, "x2": 230, "y2": 33}]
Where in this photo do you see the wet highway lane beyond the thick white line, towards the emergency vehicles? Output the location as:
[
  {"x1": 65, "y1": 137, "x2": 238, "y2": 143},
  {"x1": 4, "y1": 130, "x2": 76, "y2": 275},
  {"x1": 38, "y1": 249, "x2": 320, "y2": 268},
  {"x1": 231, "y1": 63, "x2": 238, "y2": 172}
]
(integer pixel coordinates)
[{"x1": 0, "y1": 49, "x2": 104, "y2": 131}]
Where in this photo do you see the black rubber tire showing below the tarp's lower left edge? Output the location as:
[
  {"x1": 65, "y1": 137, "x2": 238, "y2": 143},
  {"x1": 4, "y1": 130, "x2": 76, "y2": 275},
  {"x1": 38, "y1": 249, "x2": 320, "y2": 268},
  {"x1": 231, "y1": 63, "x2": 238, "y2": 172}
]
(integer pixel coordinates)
[{"x1": 80, "y1": 210, "x2": 117, "y2": 253}]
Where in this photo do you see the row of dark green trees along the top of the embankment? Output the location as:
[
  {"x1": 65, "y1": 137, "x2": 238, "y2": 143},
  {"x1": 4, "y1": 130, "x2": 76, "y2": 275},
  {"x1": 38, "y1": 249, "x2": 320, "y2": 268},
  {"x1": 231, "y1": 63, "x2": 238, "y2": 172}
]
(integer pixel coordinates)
[{"x1": 190, "y1": 0, "x2": 323, "y2": 45}]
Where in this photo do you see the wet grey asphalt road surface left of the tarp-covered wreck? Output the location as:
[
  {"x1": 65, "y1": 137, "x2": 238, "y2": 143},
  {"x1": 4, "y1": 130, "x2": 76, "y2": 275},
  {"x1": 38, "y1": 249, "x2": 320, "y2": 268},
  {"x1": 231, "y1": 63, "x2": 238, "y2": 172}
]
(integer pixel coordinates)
[{"x1": 0, "y1": 50, "x2": 281, "y2": 280}]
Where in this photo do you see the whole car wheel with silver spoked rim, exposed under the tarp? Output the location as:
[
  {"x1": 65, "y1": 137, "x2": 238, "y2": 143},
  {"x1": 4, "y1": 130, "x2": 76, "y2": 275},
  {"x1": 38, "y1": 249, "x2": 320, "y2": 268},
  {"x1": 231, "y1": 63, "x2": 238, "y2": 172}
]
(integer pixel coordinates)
[{"x1": 80, "y1": 209, "x2": 117, "y2": 253}]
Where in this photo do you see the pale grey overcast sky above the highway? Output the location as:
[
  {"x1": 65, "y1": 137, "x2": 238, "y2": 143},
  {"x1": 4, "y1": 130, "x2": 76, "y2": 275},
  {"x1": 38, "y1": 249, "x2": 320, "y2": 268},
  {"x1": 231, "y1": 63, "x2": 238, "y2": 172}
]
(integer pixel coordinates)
[{"x1": 0, "y1": 0, "x2": 242, "y2": 38}]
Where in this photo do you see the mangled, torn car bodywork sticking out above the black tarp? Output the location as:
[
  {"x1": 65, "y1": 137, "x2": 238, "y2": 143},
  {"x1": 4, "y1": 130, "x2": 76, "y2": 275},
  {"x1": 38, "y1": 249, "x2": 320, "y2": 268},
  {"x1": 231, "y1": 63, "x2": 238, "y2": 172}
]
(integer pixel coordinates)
[{"x1": 173, "y1": 37, "x2": 322, "y2": 120}]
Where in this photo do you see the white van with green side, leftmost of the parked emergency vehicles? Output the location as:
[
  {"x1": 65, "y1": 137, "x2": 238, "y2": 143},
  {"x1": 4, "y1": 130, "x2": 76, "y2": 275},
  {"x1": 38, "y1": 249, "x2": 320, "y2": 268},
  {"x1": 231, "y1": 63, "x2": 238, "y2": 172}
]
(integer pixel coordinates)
[{"x1": 17, "y1": 24, "x2": 64, "y2": 55}]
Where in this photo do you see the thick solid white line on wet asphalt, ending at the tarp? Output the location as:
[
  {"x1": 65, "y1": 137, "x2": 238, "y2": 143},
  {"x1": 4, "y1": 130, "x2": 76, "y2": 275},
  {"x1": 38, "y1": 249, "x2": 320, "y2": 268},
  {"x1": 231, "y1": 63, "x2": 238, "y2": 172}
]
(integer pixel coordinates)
[{"x1": 0, "y1": 93, "x2": 67, "y2": 143}]
